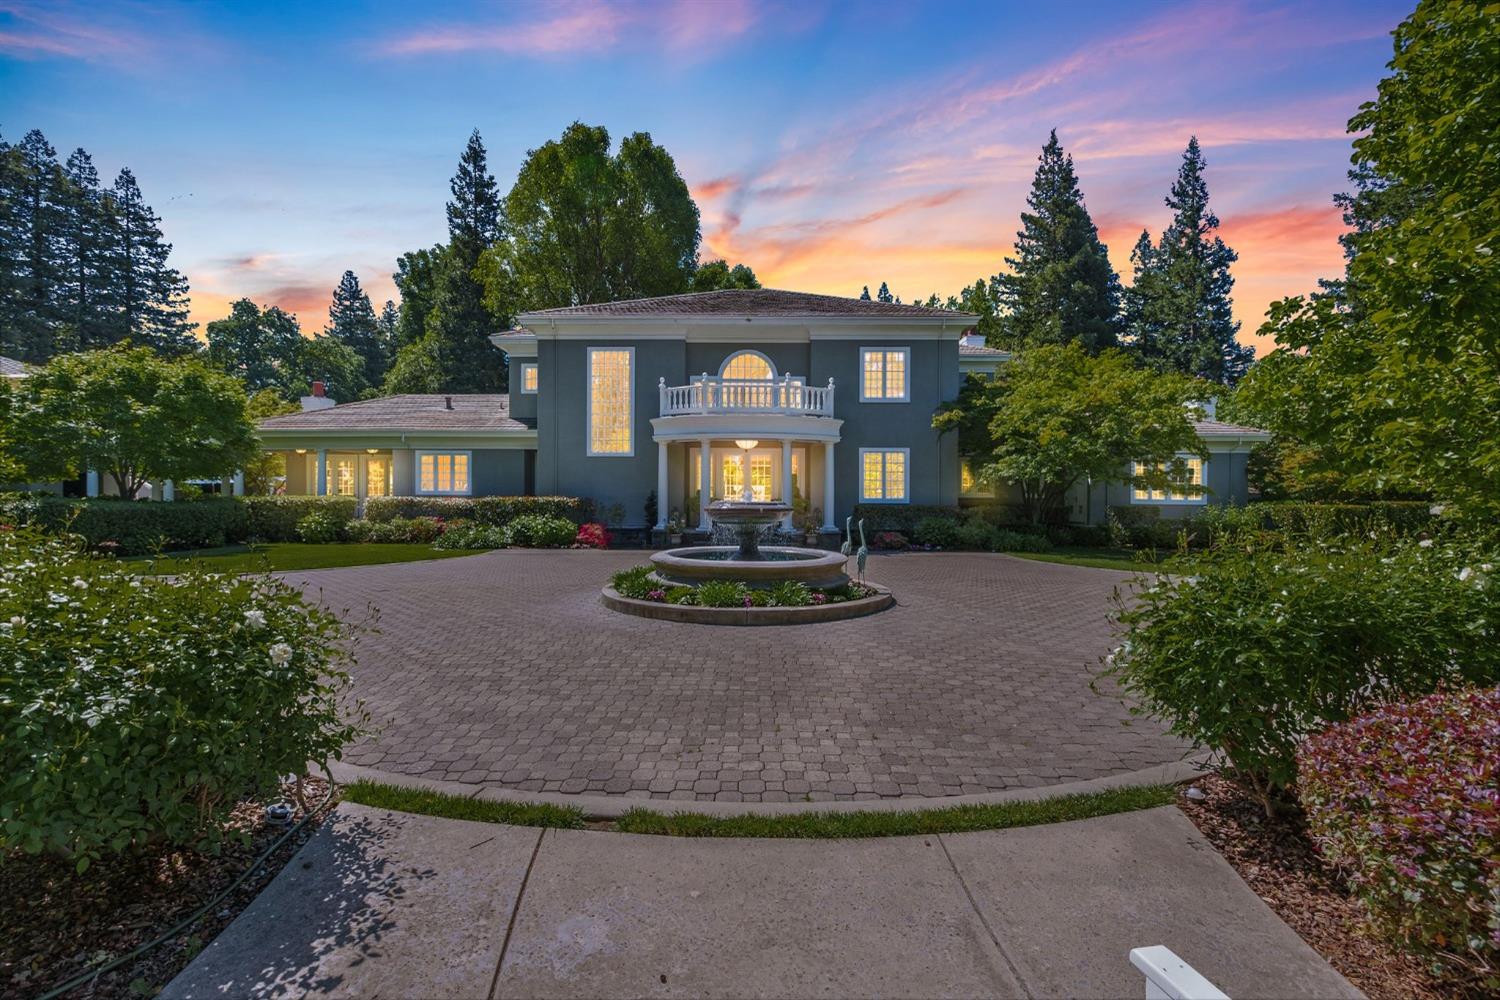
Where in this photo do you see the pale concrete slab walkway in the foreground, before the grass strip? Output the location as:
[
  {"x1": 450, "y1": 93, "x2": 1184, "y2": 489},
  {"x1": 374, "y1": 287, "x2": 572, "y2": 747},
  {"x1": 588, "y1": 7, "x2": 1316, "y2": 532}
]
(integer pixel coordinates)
[{"x1": 162, "y1": 805, "x2": 1359, "y2": 1000}]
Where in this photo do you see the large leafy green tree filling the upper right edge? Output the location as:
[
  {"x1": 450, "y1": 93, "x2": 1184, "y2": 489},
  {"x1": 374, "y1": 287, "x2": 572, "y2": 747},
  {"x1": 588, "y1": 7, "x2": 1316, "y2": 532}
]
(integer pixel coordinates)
[{"x1": 1251, "y1": 0, "x2": 1500, "y2": 515}]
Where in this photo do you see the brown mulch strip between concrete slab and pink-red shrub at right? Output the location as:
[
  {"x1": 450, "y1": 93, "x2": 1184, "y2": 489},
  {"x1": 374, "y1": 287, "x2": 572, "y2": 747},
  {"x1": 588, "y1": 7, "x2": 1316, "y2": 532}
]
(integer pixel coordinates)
[{"x1": 1178, "y1": 775, "x2": 1457, "y2": 1000}]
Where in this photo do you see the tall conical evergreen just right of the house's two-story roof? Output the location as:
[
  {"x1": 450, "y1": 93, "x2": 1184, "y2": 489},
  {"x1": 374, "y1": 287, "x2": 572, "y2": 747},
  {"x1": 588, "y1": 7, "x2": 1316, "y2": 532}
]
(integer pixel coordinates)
[{"x1": 995, "y1": 130, "x2": 1121, "y2": 354}]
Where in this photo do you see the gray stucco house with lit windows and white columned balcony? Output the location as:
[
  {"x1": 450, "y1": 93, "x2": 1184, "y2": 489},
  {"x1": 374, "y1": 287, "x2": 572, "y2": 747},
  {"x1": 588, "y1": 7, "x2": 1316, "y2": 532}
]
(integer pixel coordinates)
[{"x1": 260, "y1": 289, "x2": 1266, "y2": 531}]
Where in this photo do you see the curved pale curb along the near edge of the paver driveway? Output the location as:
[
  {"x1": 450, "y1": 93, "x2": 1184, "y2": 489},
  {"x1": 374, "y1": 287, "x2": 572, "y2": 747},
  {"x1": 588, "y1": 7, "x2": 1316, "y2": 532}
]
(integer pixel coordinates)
[{"x1": 329, "y1": 753, "x2": 1209, "y2": 820}]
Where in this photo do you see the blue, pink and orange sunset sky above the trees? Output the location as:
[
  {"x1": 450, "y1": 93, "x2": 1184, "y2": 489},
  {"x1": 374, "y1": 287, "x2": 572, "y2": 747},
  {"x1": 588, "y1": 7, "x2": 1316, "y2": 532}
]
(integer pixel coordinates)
[{"x1": 0, "y1": 0, "x2": 1412, "y2": 349}]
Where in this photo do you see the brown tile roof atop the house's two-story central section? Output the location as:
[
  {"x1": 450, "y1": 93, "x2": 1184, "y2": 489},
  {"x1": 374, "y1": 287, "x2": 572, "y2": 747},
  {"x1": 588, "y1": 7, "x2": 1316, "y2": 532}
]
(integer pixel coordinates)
[{"x1": 522, "y1": 288, "x2": 978, "y2": 321}]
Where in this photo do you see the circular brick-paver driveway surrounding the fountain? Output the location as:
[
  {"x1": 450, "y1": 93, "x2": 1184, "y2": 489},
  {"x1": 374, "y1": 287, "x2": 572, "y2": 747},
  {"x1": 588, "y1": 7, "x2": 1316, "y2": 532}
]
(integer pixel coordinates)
[{"x1": 290, "y1": 549, "x2": 1185, "y2": 802}]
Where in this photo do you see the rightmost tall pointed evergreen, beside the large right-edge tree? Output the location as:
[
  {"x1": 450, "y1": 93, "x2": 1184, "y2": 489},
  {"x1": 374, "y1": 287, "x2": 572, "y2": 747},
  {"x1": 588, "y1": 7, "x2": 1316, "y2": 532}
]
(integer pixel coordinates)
[{"x1": 1125, "y1": 136, "x2": 1256, "y2": 385}]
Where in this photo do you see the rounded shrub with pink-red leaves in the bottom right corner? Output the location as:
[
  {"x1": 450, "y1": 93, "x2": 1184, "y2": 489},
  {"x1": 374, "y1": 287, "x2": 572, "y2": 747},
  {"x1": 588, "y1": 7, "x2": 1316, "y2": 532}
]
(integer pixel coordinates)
[{"x1": 1298, "y1": 688, "x2": 1500, "y2": 990}]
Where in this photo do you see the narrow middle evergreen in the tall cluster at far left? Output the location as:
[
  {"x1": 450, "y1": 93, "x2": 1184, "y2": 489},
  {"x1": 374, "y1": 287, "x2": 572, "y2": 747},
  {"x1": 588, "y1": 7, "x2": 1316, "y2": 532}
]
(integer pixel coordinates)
[{"x1": 57, "y1": 148, "x2": 114, "y2": 351}]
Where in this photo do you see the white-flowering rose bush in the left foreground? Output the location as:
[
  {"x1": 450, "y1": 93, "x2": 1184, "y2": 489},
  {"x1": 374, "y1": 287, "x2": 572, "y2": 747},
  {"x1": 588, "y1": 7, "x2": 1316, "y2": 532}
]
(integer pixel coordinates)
[{"x1": 0, "y1": 529, "x2": 363, "y2": 870}]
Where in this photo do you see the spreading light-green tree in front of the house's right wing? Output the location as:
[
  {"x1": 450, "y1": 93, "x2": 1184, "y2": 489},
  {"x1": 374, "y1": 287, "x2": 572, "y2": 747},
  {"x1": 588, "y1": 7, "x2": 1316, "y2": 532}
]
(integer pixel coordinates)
[{"x1": 933, "y1": 342, "x2": 1205, "y2": 525}]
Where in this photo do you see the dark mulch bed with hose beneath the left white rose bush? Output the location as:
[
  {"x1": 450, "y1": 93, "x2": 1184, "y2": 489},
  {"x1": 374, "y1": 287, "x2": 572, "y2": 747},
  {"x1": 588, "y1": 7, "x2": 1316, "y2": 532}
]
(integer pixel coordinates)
[{"x1": 0, "y1": 780, "x2": 327, "y2": 1000}]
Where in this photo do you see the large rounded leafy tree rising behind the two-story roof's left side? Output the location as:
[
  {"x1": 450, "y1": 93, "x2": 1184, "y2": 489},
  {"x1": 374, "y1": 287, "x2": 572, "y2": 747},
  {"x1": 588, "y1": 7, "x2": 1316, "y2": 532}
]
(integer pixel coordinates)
[{"x1": 480, "y1": 121, "x2": 699, "y2": 315}]
